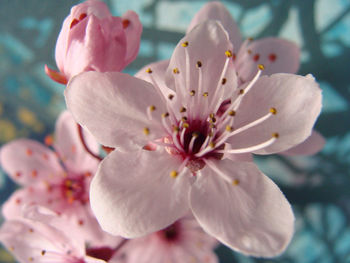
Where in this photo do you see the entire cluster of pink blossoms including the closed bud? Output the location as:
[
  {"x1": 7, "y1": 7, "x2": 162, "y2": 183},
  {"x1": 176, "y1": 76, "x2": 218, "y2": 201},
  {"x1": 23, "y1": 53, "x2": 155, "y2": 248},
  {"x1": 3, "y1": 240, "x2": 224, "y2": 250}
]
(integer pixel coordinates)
[{"x1": 0, "y1": 0, "x2": 324, "y2": 263}]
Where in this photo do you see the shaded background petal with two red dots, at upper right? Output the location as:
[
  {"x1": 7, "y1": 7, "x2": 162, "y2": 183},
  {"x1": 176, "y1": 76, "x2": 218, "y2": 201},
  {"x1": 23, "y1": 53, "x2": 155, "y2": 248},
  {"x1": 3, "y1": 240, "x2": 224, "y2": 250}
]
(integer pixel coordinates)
[{"x1": 235, "y1": 37, "x2": 300, "y2": 82}]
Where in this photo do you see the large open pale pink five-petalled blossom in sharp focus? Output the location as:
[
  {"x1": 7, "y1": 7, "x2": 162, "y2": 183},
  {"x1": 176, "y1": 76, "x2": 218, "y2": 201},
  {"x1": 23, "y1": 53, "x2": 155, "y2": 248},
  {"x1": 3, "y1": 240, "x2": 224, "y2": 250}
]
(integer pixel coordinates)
[{"x1": 65, "y1": 21, "x2": 321, "y2": 257}]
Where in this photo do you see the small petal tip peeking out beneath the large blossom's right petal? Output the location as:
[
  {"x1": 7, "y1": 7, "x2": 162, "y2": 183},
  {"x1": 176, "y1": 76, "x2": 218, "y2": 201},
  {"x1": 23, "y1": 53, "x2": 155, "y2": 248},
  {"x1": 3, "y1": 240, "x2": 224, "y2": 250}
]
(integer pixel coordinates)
[{"x1": 281, "y1": 130, "x2": 326, "y2": 156}]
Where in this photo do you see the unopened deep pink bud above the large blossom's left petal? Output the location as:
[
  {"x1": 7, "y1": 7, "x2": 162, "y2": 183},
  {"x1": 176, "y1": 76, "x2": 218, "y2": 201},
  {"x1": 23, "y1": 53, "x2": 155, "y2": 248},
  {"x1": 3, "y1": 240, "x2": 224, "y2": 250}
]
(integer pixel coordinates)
[{"x1": 45, "y1": 0, "x2": 142, "y2": 84}]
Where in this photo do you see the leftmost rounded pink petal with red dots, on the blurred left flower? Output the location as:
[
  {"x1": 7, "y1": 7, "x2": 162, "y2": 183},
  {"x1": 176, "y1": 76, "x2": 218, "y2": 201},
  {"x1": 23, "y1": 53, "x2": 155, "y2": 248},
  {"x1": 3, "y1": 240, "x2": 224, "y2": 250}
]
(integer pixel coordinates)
[{"x1": 0, "y1": 139, "x2": 63, "y2": 185}]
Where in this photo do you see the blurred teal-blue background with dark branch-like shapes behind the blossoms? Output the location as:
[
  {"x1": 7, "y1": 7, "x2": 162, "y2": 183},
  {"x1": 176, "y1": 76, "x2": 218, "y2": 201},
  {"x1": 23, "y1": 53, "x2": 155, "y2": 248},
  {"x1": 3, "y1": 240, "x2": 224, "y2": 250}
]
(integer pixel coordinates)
[{"x1": 0, "y1": 0, "x2": 350, "y2": 263}]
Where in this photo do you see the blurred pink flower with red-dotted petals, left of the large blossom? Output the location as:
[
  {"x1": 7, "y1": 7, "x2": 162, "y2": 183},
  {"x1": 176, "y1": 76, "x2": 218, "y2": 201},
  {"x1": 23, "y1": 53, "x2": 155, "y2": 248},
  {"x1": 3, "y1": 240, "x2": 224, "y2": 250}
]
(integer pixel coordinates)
[{"x1": 0, "y1": 111, "x2": 100, "y2": 245}]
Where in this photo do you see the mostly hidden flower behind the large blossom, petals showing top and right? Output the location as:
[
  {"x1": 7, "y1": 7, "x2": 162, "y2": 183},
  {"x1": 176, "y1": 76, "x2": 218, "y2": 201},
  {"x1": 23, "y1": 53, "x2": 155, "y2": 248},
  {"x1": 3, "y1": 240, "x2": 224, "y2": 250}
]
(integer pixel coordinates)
[{"x1": 187, "y1": 2, "x2": 325, "y2": 155}]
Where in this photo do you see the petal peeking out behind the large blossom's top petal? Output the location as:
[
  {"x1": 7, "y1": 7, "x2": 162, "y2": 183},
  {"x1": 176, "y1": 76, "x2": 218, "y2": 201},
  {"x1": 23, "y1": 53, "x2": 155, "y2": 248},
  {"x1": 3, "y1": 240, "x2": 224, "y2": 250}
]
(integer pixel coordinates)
[{"x1": 187, "y1": 2, "x2": 242, "y2": 52}]
